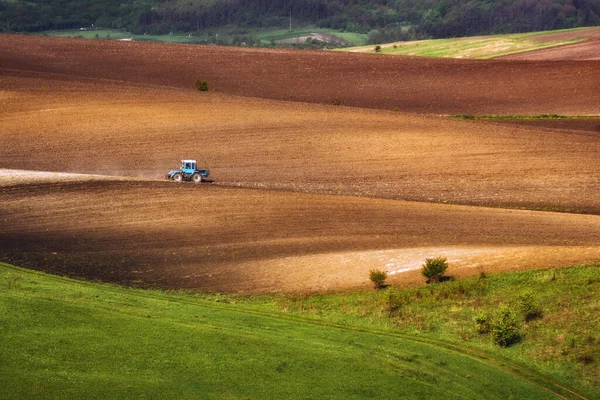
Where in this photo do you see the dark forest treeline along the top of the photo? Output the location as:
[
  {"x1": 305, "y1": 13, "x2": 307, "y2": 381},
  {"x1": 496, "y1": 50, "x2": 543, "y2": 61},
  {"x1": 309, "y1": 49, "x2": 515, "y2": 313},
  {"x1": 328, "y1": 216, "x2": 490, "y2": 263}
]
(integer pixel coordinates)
[{"x1": 0, "y1": 0, "x2": 600, "y2": 43}]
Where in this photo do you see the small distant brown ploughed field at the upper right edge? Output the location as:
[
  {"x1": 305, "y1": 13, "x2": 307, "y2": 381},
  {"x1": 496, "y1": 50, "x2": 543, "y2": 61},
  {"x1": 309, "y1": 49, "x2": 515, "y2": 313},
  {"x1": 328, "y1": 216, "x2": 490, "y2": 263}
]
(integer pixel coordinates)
[{"x1": 500, "y1": 28, "x2": 600, "y2": 61}]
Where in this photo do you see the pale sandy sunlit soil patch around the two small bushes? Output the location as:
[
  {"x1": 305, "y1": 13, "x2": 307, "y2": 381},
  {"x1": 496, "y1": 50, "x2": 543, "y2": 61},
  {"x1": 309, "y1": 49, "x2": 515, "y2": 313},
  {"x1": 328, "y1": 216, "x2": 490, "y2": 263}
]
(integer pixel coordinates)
[{"x1": 232, "y1": 246, "x2": 600, "y2": 292}]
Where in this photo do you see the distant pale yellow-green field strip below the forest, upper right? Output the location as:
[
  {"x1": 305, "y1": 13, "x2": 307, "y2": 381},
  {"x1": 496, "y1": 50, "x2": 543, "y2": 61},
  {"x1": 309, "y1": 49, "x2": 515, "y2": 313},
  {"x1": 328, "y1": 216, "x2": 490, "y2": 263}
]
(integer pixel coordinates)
[{"x1": 339, "y1": 28, "x2": 589, "y2": 59}]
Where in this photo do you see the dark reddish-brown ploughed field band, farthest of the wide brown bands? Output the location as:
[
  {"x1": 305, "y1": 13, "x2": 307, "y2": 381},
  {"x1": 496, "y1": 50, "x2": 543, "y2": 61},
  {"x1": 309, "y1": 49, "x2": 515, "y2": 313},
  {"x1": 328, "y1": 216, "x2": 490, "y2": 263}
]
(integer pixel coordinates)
[{"x1": 0, "y1": 35, "x2": 600, "y2": 115}]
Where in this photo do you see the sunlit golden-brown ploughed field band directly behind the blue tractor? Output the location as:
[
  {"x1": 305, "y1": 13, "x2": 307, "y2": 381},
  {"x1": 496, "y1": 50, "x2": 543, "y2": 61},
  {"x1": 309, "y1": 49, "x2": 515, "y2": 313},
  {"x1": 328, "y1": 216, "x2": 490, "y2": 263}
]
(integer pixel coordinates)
[{"x1": 0, "y1": 73, "x2": 600, "y2": 213}]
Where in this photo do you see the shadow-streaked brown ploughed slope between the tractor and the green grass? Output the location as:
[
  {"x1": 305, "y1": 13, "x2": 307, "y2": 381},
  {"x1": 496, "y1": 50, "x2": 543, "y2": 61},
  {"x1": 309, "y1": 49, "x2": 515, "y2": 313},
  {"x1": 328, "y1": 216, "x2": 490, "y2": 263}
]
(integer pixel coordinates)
[{"x1": 0, "y1": 181, "x2": 600, "y2": 291}]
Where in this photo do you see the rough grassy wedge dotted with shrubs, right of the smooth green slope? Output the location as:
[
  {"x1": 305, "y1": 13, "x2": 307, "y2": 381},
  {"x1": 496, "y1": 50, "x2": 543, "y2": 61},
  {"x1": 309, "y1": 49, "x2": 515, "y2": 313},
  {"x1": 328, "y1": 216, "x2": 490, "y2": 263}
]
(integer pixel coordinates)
[{"x1": 268, "y1": 263, "x2": 600, "y2": 392}]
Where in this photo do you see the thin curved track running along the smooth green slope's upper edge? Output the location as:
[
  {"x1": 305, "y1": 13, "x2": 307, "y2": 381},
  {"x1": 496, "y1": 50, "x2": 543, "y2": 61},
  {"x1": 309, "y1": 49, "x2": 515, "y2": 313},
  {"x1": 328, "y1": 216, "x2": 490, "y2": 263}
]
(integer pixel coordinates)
[{"x1": 0, "y1": 262, "x2": 587, "y2": 400}]
